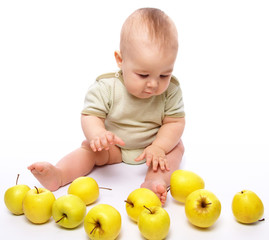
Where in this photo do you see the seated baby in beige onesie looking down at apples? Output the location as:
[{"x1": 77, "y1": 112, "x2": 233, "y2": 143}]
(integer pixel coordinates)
[{"x1": 28, "y1": 8, "x2": 185, "y2": 204}]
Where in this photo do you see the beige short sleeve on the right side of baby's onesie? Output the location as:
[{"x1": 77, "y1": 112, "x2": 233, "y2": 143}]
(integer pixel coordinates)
[{"x1": 164, "y1": 77, "x2": 185, "y2": 117}]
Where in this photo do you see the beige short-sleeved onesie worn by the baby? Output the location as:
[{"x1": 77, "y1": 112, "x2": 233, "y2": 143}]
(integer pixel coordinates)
[{"x1": 82, "y1": 72, "x2": 185, "y2": 164}]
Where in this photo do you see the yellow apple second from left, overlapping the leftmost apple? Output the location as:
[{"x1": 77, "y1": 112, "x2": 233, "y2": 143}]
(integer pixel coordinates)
[{"x1": 22, "y1": 188, "x2": 55, "y2": 224}]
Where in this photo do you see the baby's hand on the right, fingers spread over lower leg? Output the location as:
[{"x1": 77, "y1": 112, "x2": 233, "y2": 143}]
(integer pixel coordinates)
[{"x1": 135, "y1": 145, "x2": 170, "y2": 172}]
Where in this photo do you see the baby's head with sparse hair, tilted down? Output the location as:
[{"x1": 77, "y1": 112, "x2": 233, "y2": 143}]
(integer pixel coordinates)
[{"x1": 115, "y1": 8, "x2": 178, "y2": 98}]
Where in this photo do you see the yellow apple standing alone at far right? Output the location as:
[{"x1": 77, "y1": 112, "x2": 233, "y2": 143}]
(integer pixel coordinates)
[{"x1": 232, "y1": 190, "x2": 264, "y2": 223}]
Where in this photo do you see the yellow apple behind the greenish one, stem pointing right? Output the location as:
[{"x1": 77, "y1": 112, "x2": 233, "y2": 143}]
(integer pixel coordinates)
[{"x1": 68, "y1": 176, "x2": 104, "y2": 205}]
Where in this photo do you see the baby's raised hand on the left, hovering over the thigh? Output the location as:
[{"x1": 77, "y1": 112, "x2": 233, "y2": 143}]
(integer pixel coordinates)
[{"x1": 90, "y1": 131, "x2": 125, "y2": 152}]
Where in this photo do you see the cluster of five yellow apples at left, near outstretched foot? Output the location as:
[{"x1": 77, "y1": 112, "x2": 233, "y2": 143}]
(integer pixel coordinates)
[{"x1": 4, "y1": 175, "x2": 121, "y2": 240}]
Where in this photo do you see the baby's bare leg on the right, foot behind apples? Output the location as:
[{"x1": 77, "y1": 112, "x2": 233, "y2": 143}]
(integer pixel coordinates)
[{"x1": 141, "y1": 141, "x2": 184, "y2": 205}]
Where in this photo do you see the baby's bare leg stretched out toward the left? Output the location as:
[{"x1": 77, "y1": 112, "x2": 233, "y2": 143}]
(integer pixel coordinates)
[{"x1": 28, "y1": 141, "x2": 121, "y2": 191}]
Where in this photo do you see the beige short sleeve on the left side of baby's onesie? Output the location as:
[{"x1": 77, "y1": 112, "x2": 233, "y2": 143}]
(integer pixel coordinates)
[{"x1": 81, "y1": 79, "x2": 111, "y2": 118}]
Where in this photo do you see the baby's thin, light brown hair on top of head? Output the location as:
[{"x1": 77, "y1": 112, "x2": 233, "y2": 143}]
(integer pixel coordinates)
[{"x1": 120, "y1": 8, "x2": 178, "y2": 54}]
